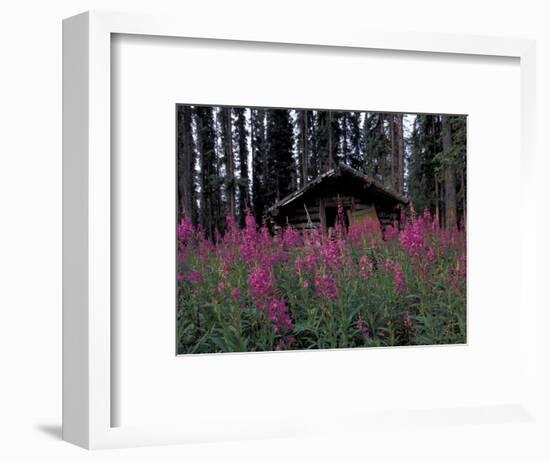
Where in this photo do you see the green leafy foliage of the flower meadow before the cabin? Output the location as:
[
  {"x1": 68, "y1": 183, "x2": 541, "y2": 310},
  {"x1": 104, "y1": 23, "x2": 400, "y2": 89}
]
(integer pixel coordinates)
[{"x1": 177, "y1": 217, "x2": 466, "y2": 354}]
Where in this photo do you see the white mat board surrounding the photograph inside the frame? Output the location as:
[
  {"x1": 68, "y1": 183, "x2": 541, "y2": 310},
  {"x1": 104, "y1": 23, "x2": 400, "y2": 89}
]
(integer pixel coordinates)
[{"x1": 112, "y1": 36, "x2": 530, "y2": 432}]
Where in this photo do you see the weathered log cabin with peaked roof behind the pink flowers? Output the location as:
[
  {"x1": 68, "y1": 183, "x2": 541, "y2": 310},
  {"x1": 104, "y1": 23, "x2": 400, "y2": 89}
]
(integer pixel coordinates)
[{"x1": 266, "y1": 163, "x2": 408, "y2": 232}]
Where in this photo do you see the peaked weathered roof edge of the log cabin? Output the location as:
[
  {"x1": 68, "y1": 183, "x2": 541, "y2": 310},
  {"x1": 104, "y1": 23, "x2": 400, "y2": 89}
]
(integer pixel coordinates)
[{"x1": 267, "y1": 163, "x2": 408, "y2": 214}]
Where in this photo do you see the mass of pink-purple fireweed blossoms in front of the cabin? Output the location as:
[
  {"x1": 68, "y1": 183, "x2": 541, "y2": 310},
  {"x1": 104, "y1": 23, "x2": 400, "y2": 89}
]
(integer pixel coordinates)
[{"x1": 176, "y1": 211, "x2": 466, "y2": 349}]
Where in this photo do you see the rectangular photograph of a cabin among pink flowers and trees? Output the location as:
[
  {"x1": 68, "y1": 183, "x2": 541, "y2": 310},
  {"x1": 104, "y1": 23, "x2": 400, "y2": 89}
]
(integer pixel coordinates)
[{"x1": 174, "y1": 104, "x2": 467, "y2": 355}]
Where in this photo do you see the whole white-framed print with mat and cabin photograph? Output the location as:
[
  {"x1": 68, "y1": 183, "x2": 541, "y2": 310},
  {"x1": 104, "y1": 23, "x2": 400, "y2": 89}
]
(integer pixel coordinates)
[{"x1": 63, "y1": 12, "x2": 537, "y2": 448}]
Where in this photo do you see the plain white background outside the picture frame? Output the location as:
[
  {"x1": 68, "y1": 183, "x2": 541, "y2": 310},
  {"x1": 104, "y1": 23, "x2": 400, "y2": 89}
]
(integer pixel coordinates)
[{"x1": 0, "y1": 0, "x2": 550, "y2": 460}]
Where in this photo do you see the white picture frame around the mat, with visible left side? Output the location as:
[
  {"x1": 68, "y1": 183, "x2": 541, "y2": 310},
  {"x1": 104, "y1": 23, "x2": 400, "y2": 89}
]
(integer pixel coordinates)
[{"x1": 63, "y1": 12, "x2": 537, "y2": 449}]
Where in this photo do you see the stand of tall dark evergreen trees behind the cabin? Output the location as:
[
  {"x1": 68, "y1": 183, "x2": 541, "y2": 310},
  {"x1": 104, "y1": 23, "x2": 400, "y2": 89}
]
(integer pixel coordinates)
[{"x1": 176, "y1": 105, "x2": 467, "y2": 238}]
